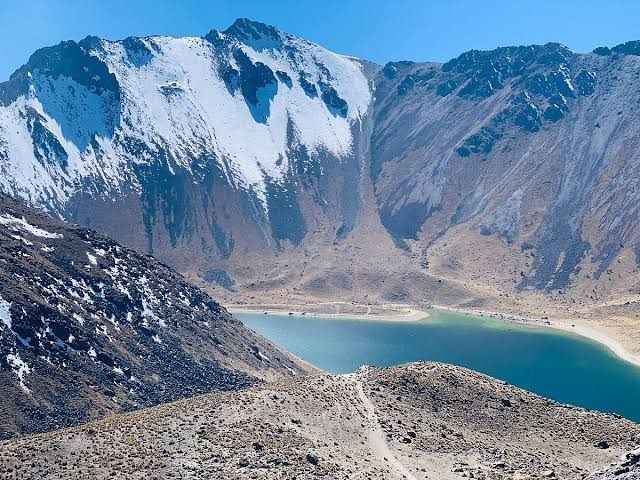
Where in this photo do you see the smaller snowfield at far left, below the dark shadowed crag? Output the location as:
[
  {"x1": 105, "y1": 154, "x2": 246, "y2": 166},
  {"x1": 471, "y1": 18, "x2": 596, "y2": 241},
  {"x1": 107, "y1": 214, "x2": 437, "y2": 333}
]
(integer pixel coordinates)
[{"x1": 0, "y1": 77, "x2": 126, "y2": 213}]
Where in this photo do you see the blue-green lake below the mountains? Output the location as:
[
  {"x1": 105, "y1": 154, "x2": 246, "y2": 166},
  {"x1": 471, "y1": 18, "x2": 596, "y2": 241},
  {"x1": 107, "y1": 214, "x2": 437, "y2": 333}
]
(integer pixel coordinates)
[{"x1": 236, "y1": 310, "x2": 640, "y2": 422}]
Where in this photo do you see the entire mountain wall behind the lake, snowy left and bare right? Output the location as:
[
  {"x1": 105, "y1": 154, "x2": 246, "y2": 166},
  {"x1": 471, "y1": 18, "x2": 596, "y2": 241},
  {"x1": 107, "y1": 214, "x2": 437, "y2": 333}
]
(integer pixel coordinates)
[{"x1": 0, "y1": 20, "x2": 640, "y2": 316}]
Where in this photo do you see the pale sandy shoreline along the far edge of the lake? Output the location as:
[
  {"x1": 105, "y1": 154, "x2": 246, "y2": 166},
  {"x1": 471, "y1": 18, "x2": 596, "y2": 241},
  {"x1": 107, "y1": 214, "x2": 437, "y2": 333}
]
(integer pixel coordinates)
[{"x1": 227, "y1": 302, "x2": 640, "y2": 368}]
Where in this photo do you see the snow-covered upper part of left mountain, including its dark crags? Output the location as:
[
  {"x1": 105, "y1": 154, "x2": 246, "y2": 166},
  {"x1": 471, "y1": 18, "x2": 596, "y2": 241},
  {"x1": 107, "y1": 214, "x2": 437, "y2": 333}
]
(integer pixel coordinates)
[{"x1": 0, "y1": 19, "x2": 371, "y2": 249}]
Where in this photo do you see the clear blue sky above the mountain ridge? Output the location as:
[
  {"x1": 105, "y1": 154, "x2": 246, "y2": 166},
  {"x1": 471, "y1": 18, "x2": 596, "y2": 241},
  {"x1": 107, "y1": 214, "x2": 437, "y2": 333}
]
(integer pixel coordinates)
[{"x1": 0, "y1": 0, "x2": 640, "y2": 80}]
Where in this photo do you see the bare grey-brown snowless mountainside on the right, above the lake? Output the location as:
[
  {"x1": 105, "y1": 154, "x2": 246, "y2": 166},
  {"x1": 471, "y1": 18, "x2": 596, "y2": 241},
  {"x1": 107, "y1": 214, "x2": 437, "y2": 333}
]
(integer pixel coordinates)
[{"x1": 372, "y1": 44, "x2": 640, "y2": 296}]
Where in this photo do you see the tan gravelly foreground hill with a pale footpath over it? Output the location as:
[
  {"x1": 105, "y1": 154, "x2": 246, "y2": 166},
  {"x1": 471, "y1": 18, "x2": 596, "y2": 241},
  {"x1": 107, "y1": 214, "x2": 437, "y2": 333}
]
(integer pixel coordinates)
[{"x1": 0, "y1": 363, "x2": 640, "y2": 480}]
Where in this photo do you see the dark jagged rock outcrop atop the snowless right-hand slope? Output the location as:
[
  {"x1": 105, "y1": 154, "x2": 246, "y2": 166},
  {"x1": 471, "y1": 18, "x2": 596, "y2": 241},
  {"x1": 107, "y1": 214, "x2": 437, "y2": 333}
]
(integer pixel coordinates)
[{"x1": 398, "y1": 43, "x2": 596, "y2": 157}]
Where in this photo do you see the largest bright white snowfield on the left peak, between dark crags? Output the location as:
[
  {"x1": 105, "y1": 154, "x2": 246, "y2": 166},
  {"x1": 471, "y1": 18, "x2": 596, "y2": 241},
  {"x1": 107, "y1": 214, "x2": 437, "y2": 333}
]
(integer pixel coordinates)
[{"x1": 97, "y1": 31, "x2": 371, "y2": 203}]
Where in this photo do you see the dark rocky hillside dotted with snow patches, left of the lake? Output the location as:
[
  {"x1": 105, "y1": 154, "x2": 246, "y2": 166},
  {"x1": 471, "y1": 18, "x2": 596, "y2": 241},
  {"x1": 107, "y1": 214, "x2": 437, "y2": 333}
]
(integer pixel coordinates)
[{"x1": 0, "y1": 196, "x2": 301, "y2": 438}]
